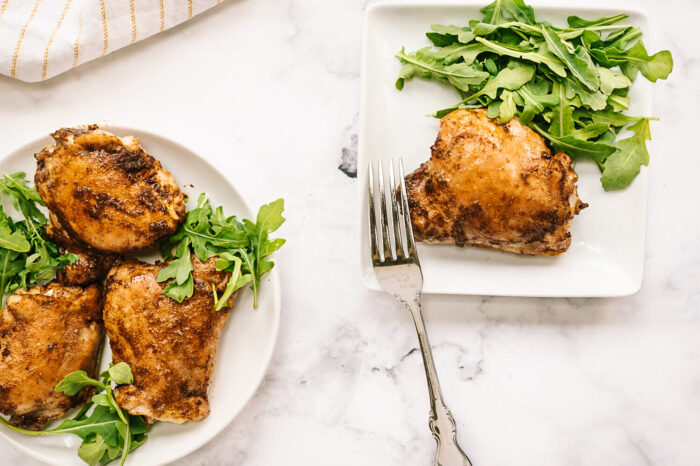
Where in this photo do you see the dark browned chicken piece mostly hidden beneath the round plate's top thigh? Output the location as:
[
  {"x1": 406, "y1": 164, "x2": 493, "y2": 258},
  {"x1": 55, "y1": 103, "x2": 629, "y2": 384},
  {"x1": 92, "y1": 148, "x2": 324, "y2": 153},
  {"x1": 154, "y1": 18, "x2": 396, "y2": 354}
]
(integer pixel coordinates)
[{"x1": 46, "y1": 213, "x2": 119, "y2": 286}]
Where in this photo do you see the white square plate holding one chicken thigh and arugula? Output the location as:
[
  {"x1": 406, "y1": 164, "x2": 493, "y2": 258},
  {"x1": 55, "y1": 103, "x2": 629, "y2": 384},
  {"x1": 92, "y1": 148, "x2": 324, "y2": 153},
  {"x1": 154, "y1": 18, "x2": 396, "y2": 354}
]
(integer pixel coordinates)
[{"x1": 358, "y1": 0, "x2": 653, "y2": 297}]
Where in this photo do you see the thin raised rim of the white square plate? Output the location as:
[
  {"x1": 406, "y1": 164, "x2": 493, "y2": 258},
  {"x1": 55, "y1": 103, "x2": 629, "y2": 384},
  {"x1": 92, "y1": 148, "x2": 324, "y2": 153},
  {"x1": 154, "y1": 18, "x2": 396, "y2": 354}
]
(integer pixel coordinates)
[{"x1": 356, "y1": 0, "x2": 656, "y2": 298}]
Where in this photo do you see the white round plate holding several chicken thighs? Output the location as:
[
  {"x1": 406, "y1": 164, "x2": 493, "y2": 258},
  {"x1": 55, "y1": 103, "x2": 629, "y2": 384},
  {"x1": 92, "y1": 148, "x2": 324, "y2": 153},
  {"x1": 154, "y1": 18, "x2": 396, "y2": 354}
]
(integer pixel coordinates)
[{"x1": 0, "y1": 124, "x2": 281, "y2": 466}]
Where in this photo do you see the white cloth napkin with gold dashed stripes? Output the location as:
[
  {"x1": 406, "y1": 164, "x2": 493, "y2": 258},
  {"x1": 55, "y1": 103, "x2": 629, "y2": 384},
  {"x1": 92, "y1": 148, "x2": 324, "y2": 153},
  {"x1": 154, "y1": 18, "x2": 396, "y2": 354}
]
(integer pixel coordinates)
[{"x1": 0, "y1": 0, "x2": 221, "y2": 82}]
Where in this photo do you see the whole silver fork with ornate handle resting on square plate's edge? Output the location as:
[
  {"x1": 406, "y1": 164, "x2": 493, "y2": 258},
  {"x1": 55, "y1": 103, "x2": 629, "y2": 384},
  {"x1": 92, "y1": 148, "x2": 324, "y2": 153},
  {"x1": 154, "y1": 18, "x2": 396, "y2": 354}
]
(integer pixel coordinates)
[{"x1": 369, "y1": 159, "x2": 471, "y2": 466}]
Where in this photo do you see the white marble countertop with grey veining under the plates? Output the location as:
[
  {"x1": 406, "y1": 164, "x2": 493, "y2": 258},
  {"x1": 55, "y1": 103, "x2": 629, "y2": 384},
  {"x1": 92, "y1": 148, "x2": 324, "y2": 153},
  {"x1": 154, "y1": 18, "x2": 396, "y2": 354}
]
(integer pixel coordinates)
[{"x1": 0, "y1": 0, "x2": 700, "y2": 466}]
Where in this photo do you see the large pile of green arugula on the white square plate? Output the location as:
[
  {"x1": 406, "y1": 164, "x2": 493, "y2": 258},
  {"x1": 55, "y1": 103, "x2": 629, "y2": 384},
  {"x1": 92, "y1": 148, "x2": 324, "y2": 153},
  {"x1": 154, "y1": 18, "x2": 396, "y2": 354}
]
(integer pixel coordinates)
[{"x1": 396, "y1": 0, "x2": 673, "y2": 191}]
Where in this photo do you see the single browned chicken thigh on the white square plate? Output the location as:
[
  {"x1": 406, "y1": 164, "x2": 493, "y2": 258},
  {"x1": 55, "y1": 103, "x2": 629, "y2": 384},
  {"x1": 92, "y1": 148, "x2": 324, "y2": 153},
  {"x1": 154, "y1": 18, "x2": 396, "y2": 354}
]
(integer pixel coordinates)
[{"x1": 406, "y1": 109, "x2": 587, "y2": 256}]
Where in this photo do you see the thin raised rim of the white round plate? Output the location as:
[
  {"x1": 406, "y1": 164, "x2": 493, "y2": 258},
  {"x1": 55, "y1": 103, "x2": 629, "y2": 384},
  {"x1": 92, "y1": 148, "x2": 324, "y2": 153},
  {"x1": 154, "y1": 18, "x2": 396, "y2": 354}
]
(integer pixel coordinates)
[{"x1": 0, "y1": 120, "x2": 282, "y2": 466}]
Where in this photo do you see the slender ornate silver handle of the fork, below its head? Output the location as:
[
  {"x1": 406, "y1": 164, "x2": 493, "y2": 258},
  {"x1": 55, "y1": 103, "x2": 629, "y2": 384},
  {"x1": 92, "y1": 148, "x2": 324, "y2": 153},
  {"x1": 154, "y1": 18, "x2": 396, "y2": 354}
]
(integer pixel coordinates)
[{"x1": 404, "y1": 294, "x2": 472, "y2": 466}]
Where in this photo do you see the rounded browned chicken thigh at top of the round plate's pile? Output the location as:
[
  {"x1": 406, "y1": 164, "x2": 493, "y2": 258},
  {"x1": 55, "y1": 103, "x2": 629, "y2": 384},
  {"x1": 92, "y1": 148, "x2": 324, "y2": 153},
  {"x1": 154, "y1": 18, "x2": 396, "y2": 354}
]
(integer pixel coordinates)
[{"x1": 34, "y1": 125, "x2": 185, "y2": 253}]
